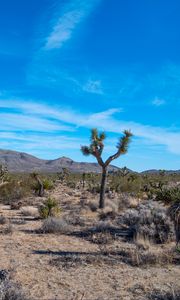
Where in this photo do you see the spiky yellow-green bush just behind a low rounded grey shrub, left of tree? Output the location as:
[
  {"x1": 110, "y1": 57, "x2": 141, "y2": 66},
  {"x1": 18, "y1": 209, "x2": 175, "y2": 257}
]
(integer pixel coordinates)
[{"x1": 39, "y1": 197, "x2": 61, "y2": 219}]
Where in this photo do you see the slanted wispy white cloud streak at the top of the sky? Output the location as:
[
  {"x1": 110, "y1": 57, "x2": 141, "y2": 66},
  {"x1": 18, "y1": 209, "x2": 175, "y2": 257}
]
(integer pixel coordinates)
[{"x1": 44, "y1": 0, "x2": 99, "y2": 50}]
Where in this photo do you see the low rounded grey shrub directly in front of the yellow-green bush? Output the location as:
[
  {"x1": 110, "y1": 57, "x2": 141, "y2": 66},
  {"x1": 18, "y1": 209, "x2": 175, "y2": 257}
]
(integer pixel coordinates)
[{"x1": 40, "y1": 217, "x2": 70, "y2": 234}]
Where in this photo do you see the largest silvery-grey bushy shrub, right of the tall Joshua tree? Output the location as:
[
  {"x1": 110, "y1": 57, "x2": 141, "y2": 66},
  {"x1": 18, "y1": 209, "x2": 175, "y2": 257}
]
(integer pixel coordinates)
[{"x1": 117, "y1": 201, "x2": 174, "y2": 243}]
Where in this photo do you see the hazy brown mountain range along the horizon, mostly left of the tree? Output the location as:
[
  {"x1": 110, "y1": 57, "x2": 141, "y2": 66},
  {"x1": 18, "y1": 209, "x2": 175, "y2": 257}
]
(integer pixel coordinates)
[{"x1": 0, "y1": 150, "x2": 119, "y2": 173}]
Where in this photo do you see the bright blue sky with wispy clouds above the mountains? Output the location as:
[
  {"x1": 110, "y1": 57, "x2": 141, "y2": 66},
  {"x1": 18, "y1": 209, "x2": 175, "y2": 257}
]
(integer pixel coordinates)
[{"x1": 0, "y1": 0, "x2": 180, "y2": 171}]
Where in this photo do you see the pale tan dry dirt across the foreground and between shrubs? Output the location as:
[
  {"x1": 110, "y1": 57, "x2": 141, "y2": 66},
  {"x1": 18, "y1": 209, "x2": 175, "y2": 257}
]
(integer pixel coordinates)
[{"x1": 0, "y1": 185, "x2": 180, "y2": 300}]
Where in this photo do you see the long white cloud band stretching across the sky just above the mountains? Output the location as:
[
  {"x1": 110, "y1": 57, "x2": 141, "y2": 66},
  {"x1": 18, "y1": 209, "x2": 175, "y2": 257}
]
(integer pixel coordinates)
[{"x1": 0, "y1": 101, "x2": 180, "y2": 154}]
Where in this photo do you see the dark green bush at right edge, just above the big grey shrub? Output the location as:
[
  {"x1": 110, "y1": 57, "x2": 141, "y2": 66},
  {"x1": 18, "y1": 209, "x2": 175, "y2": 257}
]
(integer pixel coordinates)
[{"x1": 155, "y1": 187, "x2": 180, "y2": 204}]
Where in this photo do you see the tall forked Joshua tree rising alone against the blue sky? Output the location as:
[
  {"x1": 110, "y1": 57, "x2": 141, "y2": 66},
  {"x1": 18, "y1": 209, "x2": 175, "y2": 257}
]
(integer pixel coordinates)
[{"x1": 81, "y1": 128, "x2": 132, "y2": 208}]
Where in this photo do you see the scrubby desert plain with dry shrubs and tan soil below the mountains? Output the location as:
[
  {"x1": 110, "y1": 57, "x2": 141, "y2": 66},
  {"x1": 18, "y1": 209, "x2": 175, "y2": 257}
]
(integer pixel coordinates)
[{"x1": 0, "y1": 153, "x2": 180, "y2": 300}]
